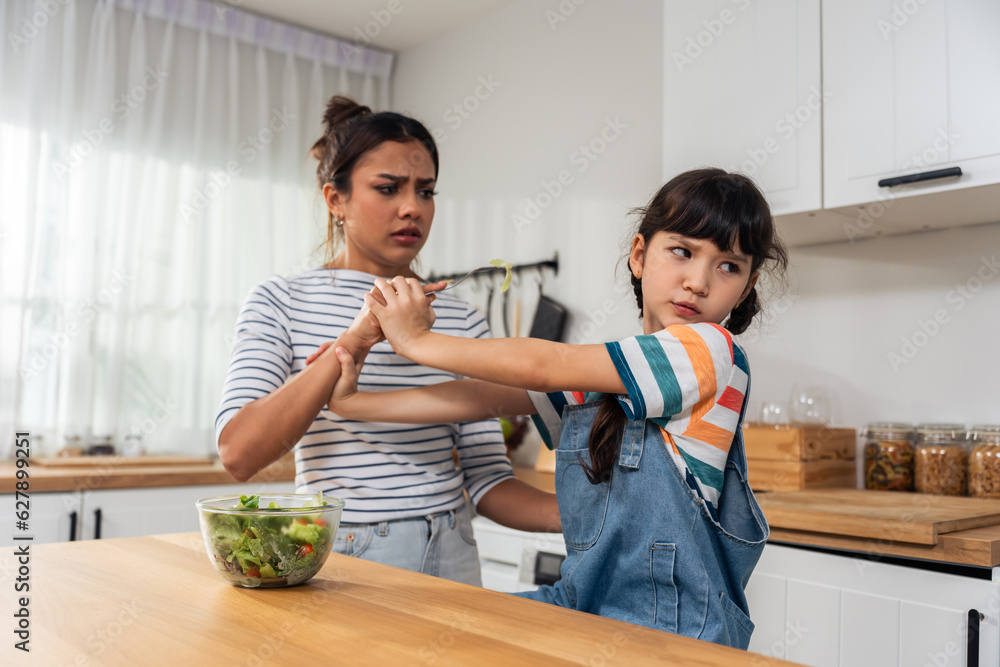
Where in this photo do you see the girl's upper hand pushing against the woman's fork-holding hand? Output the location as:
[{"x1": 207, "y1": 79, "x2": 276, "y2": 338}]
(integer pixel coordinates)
[{"x1": 365, "y1": 276, "x2": 434, "y2": 353}]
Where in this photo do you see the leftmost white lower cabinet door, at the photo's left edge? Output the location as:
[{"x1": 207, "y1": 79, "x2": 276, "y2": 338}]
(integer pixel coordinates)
[{"x1": 0, "y1": 491, "x2": 82, "y2": 547}]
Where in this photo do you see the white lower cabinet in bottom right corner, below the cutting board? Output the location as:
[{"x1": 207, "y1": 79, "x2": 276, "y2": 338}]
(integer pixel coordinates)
[{"x1": 747, "y1": 544, "x2": 1000, "y2": 667}]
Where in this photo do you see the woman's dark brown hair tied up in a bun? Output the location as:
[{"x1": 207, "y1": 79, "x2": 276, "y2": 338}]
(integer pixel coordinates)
[{"x1": 309, "y1": 95, "x2": 438, "y2": 261}]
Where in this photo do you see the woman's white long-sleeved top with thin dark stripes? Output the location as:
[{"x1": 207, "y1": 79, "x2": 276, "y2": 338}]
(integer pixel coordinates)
[{"x1": 215, "y1": 269, "x2": 513, "y2": 523}]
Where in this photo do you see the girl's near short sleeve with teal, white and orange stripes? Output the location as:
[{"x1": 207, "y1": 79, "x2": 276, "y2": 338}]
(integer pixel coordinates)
[{"x1": 606, "y1": 322, "x2": 734, "y2": 434}]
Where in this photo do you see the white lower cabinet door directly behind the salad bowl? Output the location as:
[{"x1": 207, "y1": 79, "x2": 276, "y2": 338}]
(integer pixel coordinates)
[{"x1": 82, "y1": 482, "x2": 295, "y2": 539}]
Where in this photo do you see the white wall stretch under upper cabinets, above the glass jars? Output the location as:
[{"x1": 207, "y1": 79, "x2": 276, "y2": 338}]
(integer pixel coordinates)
[{"x1": 744, "y1": 224, "x2": 1000, "y2": 427}]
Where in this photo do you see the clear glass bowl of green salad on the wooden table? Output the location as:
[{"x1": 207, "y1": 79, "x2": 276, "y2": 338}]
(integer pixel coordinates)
[{"x1": 195, "y1": 493, "x2": 344, "y2": 588}]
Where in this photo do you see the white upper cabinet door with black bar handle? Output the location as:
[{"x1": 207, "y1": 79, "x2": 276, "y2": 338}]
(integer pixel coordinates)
[{"x1": 823, "y1": 0, "x2": 1000, "y2": 209}]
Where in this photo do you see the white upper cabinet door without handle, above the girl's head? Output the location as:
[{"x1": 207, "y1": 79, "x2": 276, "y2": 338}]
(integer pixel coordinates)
[{"x1": 663, "y1": 0, "x2": 823, "y2": 215}]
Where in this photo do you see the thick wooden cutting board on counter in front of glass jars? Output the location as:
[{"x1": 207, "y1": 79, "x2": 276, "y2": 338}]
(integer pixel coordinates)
[{"x1": 757, "y1": 489, "x2": 1000, "y2": 544}]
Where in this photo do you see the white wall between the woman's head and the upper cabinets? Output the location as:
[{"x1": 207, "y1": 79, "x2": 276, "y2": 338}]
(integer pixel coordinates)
[{"x1": 393, "y1": 0, "x2": 663, "y2": 342}]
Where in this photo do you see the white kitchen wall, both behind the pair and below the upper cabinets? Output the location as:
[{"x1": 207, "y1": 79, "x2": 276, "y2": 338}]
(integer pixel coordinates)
[{"x1": 394, "y1": 0, "x2": 1000, "y2": 434}]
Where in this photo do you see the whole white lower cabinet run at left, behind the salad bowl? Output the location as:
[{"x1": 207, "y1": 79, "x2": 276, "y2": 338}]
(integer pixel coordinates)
[{"x1": 0, "y1": 481, "x2": 295, "y2": 547}]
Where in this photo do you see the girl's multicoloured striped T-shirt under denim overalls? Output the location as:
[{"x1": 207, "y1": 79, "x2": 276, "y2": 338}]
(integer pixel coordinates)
[{"x1": 529, "y1": 322, "x2": 750, "y2": 510}]
